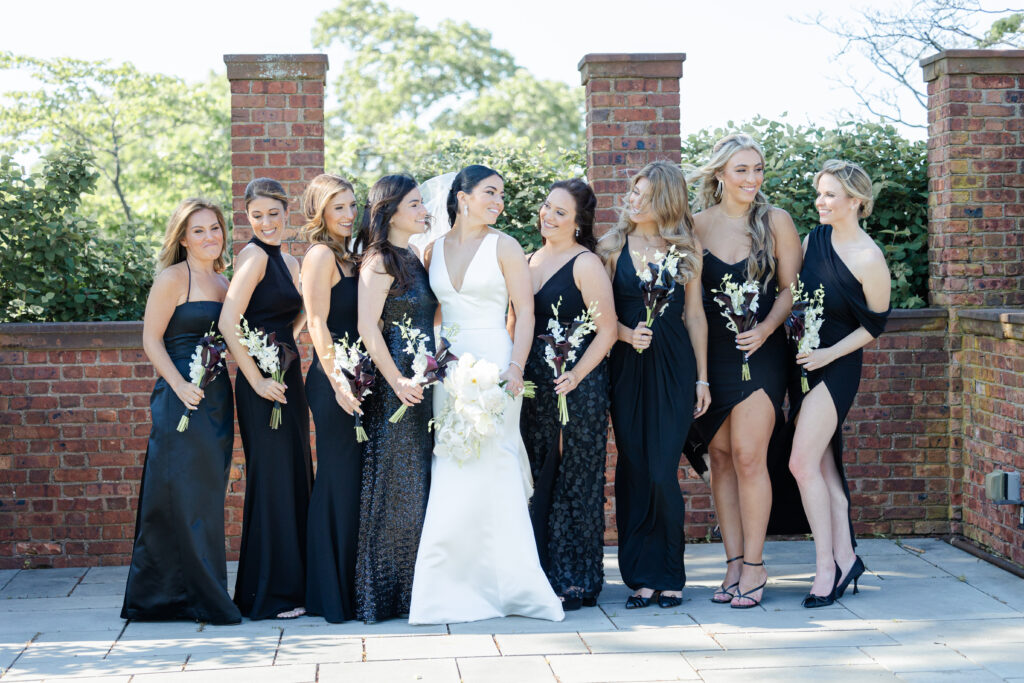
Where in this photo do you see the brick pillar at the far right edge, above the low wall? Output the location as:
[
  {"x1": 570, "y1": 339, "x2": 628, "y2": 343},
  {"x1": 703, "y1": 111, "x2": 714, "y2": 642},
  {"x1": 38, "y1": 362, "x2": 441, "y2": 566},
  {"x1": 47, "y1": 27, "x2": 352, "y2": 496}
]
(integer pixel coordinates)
[{"x1": 921, "y1": 50, "x2": 1024, "y2": 307}]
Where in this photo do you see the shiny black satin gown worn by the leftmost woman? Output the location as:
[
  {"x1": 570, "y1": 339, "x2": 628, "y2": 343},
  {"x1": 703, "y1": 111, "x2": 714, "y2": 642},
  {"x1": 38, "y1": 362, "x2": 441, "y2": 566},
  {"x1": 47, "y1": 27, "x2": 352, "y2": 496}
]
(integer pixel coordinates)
[{"x1": 121, "y1": 294, "x2": 242, "y2": 624}]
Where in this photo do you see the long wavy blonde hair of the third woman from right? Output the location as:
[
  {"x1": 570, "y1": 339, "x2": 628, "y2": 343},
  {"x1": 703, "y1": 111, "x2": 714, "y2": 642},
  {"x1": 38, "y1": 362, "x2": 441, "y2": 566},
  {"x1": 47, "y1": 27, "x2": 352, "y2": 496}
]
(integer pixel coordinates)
[{"x1": 597, "y1": 161, "x2": 700, "y2": 285}]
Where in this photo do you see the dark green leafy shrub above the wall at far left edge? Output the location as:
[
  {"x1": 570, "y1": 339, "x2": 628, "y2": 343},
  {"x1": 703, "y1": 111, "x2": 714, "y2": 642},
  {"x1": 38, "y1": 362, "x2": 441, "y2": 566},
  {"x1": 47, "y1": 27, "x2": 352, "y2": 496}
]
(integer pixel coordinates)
[{"x1": 0, "y1": 150, "x2": 153, "y2": 323}]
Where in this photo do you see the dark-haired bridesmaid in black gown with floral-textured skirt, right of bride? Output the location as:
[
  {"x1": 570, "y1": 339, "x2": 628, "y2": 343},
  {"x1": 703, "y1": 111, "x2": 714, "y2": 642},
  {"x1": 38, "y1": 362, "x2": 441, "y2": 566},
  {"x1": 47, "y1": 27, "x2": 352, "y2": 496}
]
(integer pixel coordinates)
[{"x1": 519, "y1": 179, "x2": 616, "y2": 611}]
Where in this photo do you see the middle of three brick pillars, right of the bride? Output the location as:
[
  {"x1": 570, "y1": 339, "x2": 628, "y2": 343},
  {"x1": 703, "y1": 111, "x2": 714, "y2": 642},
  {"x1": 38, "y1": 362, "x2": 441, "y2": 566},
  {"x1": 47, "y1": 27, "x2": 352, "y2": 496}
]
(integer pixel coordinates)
[{"x1": 579, "y1": 52, "x2": 686, "y2": 234}]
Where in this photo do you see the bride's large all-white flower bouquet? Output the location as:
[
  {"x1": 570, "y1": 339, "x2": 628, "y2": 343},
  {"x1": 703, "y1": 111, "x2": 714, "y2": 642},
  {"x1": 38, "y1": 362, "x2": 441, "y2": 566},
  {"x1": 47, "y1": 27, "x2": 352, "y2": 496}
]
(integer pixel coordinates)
[{"x1": 430, "y1": 353, "x2": 508, "y2": 465}]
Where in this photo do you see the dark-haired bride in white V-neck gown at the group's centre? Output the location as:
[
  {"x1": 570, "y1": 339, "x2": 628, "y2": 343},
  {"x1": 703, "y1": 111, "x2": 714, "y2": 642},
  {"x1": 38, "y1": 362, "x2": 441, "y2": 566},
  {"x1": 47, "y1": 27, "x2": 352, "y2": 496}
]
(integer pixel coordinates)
[{"x1": 409, "y1": 165, "x2": 564, "y2": 624}]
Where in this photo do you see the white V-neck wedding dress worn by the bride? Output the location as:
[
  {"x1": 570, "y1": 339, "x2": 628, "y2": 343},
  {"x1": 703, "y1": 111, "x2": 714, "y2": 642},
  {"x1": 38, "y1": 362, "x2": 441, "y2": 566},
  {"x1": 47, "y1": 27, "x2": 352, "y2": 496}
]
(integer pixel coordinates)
[{"x1": 409, "y1": 234, "x2": 565, "y2": 624}]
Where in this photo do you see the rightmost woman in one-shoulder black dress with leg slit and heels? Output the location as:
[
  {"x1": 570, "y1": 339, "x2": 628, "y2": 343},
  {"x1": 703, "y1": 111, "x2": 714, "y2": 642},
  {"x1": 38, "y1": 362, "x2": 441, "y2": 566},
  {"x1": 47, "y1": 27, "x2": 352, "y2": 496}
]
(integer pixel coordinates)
[{"x1": 790, "y1": 159, "x2": 892, "y2": 607}]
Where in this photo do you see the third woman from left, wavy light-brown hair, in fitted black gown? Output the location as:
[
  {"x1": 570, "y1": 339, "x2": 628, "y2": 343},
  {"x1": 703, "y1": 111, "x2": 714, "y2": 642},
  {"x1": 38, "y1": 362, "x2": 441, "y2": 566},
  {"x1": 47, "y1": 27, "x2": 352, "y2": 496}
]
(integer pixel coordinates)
[{"x1": 302, "y1": 173, "x2": 362, "y2": 624}]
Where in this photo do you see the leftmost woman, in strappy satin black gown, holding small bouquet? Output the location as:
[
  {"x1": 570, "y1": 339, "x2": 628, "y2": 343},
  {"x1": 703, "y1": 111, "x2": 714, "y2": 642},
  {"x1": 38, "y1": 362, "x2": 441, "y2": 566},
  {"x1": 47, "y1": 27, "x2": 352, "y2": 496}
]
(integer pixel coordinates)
[{"x1": 121, "y1": 199, "x2": 242, "y2": 624}]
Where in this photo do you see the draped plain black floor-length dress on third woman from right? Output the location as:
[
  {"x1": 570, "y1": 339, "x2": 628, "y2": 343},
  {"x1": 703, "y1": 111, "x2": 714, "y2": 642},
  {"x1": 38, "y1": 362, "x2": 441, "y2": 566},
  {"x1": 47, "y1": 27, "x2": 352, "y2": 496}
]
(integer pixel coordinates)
[{"x1": 608, "y1": 245, "x2": 696, "y2": 591}]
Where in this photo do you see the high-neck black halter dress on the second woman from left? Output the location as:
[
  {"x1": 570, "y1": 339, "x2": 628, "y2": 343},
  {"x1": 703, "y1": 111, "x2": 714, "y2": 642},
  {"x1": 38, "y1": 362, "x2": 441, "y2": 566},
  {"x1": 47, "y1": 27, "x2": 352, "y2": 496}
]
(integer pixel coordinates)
[{"x1": 234, "y1": 238, "x2": 312, "y2": 620}]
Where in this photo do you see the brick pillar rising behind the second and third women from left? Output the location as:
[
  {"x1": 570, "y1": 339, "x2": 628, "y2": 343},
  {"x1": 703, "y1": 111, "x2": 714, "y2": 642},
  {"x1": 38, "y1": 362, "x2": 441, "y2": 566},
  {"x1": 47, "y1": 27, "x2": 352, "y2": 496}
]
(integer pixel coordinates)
[{"x1": 224, "y1": 54, "x2": 328, "y2": 256}]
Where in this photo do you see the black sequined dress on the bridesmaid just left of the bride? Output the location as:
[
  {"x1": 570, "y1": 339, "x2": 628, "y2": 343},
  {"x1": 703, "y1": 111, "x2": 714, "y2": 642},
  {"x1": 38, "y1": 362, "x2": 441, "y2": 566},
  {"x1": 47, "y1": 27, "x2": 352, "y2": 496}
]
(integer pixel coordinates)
[{"x1": 355, "y1": 250, "x2": 437, "y2": 622}]
